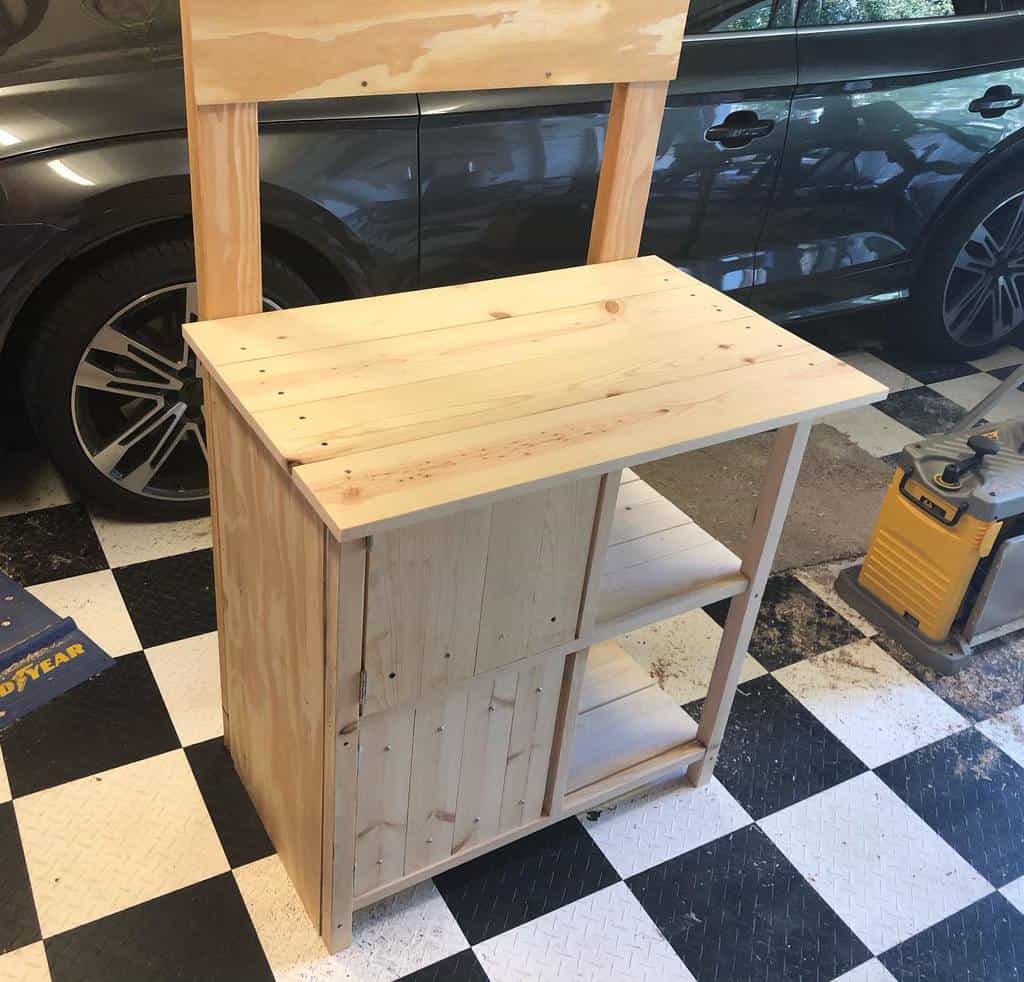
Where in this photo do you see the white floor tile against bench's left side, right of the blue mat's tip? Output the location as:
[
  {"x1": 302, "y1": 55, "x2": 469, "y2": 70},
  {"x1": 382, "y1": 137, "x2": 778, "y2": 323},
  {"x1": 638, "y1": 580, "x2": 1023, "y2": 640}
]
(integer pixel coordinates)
[{"x1": 145, "y1": 631, "x2": 224, "y2": 746}]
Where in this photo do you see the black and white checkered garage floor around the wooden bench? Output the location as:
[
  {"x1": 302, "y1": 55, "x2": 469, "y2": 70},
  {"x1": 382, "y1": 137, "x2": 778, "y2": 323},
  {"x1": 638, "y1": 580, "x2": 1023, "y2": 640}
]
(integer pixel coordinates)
[{"x1": 0, "y1": 339, "x2": 1024, "y2": 982}]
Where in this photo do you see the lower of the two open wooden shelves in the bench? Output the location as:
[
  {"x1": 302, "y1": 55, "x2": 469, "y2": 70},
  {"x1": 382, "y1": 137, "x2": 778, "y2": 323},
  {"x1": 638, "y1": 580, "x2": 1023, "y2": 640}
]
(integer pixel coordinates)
[{"x1": 566, "y1": 641, "x2": 697, "y2": 795}]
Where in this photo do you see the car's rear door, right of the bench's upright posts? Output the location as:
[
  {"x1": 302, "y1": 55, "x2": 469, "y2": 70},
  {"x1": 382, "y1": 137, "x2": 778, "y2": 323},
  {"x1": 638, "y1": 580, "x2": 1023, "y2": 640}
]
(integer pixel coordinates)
[{"x1": 752, "y1": 0, "x2": 1024, "y2": 317}]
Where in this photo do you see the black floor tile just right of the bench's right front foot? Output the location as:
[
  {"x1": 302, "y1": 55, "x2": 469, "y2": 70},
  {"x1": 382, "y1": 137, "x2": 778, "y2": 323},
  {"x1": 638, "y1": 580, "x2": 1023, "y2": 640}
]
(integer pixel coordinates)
[{"x1": 684, "y1": 675, "x2": 867, "y2": 819}]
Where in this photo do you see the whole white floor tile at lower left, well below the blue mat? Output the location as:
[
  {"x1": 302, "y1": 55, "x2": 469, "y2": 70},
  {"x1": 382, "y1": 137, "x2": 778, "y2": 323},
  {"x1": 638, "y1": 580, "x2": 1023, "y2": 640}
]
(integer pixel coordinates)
[{"x1": 14, "y1": 751, "x2": 228, "y2": 937}]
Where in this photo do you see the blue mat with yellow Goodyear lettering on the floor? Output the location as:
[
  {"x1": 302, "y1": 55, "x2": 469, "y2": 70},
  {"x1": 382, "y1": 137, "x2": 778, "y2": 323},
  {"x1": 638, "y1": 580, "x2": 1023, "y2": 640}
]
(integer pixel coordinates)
[{"x1": 0, "y1": 572, "x2": 114, "y2": 730}]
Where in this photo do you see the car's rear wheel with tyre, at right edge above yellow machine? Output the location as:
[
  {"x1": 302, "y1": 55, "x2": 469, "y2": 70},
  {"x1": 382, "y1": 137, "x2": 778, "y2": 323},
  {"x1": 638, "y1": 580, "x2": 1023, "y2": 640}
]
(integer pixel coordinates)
[{"x1": 911, "y1": 170, "x2": 1024, "y2": 360}]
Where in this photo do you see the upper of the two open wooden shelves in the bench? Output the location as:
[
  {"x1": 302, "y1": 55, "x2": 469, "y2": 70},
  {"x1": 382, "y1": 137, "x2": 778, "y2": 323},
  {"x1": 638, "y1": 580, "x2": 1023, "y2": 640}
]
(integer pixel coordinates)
[{"x1": 594, "y1": 475, "x2": 746, "y2": 641}]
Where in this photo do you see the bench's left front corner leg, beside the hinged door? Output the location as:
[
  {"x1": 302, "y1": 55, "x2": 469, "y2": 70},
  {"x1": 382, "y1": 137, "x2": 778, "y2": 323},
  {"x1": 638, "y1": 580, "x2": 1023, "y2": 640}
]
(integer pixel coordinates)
[{"x1": 321, "y1": 529, "x2": 367, "y2": 950}]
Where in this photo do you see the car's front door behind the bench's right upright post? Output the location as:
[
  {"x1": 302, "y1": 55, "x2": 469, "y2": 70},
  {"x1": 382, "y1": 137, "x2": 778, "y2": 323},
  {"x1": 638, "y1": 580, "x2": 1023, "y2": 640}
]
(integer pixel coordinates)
[{"x1": 420, "y1": 0, "x2": 796, "y2": 290}]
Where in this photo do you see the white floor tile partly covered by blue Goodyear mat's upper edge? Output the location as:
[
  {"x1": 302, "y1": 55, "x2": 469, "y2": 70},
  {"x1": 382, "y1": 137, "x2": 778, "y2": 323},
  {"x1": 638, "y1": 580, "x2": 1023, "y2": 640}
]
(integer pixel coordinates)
[{"x1": 29, "y1": 569, "x2": 142, "y2": 657}]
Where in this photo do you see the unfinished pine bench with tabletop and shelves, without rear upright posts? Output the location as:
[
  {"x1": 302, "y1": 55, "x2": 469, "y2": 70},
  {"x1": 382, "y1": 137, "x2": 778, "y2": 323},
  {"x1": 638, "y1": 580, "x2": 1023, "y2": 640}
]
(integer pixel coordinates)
[{"x1": 186, "y1": 258, "x2": 885, "y2": 947}]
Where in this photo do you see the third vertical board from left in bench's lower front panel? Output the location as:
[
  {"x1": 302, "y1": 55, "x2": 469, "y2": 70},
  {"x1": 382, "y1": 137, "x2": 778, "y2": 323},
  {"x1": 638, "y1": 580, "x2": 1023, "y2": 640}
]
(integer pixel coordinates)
[{"x1": 456, "y1": 670, "x2": 519, "y2": 851}]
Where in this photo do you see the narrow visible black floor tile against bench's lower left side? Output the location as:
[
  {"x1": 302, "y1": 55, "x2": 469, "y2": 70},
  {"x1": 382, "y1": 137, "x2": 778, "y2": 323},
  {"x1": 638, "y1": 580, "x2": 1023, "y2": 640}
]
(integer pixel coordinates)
[{"x1": 185, "y1": 737, "x2": 273, "y2": 868}]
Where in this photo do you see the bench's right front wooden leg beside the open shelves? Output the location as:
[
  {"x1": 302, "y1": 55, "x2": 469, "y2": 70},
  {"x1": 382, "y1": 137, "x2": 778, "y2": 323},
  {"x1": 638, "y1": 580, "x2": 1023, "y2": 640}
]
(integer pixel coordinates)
[{"x1": 686, "y1": 422, "x2": 811, "y2": 786}]
